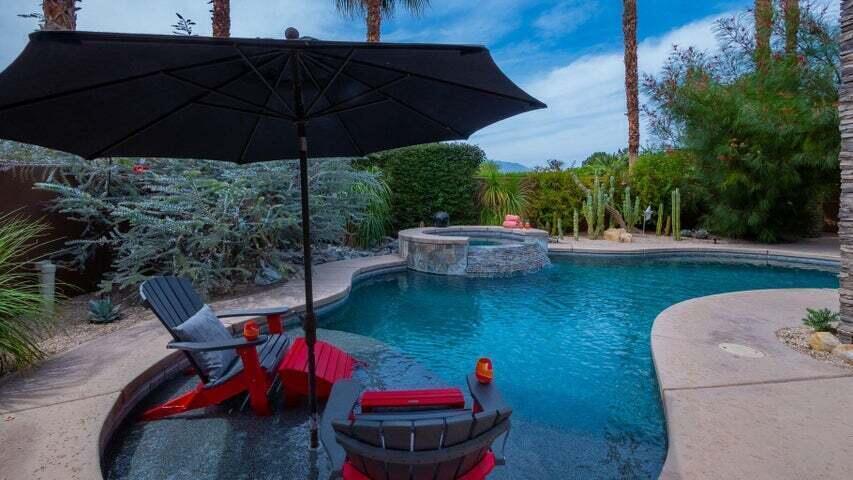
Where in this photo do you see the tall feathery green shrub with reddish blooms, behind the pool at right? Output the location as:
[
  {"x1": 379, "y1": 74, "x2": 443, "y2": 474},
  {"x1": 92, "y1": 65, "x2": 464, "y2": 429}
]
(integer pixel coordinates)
[{"x1": 645, "y1": 4, "x2": 840, "y2": 242}]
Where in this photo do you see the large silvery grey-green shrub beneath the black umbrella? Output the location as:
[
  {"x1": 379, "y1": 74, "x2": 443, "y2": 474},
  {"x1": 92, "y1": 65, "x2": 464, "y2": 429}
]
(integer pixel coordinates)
[{"x1": 38, "y1": 159, "x2": 381, "y2": 293}]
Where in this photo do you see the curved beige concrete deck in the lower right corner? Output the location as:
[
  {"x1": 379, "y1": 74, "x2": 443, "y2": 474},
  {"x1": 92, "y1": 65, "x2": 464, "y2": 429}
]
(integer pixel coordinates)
[{"x1": 651, "y1": 289, "x2": 853, "y2": 480}]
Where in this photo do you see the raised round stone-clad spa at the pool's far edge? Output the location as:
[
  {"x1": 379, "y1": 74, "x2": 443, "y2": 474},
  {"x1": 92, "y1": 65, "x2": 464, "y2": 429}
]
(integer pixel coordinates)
[{"x1": 399, "y1": 226, "x2": 551, "y2": 277}]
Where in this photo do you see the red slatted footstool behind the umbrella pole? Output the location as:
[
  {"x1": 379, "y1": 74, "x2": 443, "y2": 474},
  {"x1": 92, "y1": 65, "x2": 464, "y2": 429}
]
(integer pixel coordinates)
[{"x1": 278, "y1": 337, "x2": 355, "y2": 398}]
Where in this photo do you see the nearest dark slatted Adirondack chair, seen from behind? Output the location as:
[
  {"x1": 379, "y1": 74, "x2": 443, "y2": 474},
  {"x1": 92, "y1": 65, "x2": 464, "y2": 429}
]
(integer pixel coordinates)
[{"x1": 320, "y1": 374, "x2": 512, "y2": 480}]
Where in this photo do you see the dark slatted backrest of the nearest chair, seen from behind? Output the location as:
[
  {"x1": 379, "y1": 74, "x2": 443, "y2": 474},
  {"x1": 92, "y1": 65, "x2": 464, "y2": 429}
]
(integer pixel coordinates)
[{"x1": 332, "y1": 410, "x2": 512, "y2": 480}]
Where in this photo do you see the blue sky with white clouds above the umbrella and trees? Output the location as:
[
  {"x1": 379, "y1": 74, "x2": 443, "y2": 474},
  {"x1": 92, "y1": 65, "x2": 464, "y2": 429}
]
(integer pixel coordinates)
[{"x1": 0, "y1": 0, "x2": 838, "y2": 166}]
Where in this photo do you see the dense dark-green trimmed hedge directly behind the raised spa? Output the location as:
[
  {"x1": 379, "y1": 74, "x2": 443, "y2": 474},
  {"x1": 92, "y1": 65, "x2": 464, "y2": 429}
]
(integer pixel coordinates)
[{"x1": 361, "y1": 143, "x2": 485, "y2": 230}]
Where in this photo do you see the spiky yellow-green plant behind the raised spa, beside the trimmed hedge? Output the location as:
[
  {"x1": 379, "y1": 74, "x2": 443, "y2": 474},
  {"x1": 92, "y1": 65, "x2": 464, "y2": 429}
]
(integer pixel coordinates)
[{"x1": 477, "y1": 162, "x2": 527, "y2": 225}]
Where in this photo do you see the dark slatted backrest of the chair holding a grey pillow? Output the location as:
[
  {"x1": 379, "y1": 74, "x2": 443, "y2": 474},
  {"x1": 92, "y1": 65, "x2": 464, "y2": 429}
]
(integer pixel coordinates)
[{"x1": 139, "y1": 277, "x2": 208, "y2": 383}]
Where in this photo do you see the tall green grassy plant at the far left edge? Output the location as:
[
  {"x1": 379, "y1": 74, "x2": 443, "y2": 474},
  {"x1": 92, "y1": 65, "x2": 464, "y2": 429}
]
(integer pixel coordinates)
[{"x1": 0, "y1": 214, "x2": 48, "y2": 372}]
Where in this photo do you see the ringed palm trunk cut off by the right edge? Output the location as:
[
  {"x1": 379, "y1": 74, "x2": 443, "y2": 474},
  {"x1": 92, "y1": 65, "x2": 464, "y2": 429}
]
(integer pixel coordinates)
[{"x1": 838, "y1": 0, "x2": 853, "y2": 343}]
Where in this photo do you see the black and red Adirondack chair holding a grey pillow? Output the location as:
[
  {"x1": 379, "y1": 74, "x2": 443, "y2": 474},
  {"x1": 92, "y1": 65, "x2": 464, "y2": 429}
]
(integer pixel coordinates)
[{"x1": 139, "y1": 277, "x2": 291, "y2": 420}]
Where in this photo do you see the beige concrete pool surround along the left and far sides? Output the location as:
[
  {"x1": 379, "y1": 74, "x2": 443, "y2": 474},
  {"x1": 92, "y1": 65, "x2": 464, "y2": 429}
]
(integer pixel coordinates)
[{"x1": 0, "y1": 237, "x2": 838, "y2": 480}]
